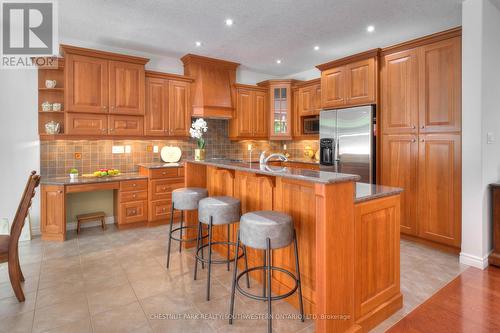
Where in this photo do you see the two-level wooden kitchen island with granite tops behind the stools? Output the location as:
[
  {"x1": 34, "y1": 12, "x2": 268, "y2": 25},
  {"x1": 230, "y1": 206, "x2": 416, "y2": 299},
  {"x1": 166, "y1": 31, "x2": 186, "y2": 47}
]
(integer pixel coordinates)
[{"x1": 185, "y1": 160, "x2": 402, "y2": 332}]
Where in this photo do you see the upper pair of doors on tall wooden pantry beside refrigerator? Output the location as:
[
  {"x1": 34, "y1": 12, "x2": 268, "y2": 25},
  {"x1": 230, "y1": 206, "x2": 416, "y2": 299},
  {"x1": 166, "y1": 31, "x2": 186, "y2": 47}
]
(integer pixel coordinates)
[{"x1": 380, "y1": 37, "x2": 461, "y2": 134}]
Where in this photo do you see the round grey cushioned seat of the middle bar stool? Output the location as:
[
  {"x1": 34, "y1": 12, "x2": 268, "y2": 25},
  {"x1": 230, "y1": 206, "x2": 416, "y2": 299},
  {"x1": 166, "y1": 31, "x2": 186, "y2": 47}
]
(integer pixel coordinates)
[{"x1": 198, "y1": 197, "x2": 240, "y2": 225}]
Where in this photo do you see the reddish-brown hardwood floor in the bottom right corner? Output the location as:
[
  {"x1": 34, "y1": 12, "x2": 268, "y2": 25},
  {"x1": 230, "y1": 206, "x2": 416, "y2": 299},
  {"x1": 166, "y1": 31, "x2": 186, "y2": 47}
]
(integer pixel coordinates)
[{"x1": 387, "y1": 266, "x2": 500, "y2": 333}]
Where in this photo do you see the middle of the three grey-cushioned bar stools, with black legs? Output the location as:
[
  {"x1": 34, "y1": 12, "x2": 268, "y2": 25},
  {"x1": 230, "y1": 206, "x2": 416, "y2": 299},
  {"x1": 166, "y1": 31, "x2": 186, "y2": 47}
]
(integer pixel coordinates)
[{"x1": 194, "y1": 196, "x2": 250, "y2": 301}]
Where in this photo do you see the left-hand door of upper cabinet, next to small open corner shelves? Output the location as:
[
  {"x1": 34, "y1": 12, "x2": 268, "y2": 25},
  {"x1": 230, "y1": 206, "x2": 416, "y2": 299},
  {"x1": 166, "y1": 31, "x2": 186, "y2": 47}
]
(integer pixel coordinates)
[{"x1": 64, "y1": 54, "x2": 108, "y2": 113}]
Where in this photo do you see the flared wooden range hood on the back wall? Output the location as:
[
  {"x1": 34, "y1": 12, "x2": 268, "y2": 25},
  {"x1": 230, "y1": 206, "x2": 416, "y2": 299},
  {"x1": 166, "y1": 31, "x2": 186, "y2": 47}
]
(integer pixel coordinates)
[{"x1": 181, "y1": 54, "x2": 240, "y2": 119}]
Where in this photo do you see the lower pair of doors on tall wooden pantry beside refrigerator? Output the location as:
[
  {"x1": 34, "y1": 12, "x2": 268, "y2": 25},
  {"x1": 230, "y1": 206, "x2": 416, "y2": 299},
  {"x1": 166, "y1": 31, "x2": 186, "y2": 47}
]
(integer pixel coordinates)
[{"x1": 380, "y1": 133, "x2": 462, "y2": 248}]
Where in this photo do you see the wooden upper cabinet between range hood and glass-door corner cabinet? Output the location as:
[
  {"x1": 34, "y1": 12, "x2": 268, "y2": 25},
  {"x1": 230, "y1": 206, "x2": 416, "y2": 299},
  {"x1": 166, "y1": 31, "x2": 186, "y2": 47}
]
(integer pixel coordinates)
[{"x1": 229, "y1": 84, "x2": 269, "y2": 139}]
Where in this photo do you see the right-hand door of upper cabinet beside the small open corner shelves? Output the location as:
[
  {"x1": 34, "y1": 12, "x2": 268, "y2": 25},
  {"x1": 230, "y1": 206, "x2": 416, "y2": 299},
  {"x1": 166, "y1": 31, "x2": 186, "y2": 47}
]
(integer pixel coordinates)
[{"x1": 109, "y1": 61, "x2": 145, "y2": 114}]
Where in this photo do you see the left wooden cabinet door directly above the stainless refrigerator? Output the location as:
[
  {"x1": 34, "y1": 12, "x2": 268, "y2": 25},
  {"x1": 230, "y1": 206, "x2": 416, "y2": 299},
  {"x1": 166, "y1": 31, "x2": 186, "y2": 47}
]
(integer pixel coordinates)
[{"x1": 321, "y1": 67, "x2": 346, "y2": 109}]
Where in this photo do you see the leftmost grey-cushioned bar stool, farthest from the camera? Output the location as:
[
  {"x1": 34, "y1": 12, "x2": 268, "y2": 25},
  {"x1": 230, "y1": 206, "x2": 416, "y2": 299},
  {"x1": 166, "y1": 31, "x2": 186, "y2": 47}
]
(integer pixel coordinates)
[{"x1": 167, "y1": 187, "x2": 208, "y2": 268}]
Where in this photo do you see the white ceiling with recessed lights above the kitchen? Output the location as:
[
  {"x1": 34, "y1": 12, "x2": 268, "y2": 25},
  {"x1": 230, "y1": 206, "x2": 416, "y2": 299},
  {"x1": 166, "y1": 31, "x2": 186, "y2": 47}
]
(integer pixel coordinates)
[{"x1": 59, "y1": 0, "x2": 461, "y2": 76}]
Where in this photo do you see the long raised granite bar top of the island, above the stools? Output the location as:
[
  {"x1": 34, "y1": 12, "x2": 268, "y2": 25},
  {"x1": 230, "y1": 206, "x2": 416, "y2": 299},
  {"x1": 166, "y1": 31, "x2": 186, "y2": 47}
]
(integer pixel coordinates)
[{"x1": 187, "y1": 159, "x2": 361, "y2": 184}]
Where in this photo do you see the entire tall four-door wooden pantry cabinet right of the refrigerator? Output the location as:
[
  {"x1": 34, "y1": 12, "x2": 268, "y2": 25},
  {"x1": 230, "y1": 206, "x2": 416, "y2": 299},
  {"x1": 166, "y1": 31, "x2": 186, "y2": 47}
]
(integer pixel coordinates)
[{"x1": 378, "y1": 29, "x2": 461, "y2": 248}]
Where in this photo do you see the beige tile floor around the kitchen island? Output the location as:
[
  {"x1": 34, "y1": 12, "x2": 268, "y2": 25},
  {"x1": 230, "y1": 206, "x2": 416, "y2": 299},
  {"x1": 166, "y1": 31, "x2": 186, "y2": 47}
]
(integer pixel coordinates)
[{"x1": 0, "y1": 226, "x2": 464, "y2": 333}]
